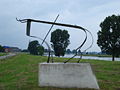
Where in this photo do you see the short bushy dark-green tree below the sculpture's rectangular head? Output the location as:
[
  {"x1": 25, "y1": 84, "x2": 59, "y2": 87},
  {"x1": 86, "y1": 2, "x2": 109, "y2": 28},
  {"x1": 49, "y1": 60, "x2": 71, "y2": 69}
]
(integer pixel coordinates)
[{"x1": 28, "y1": 40, "x2": 44, "y2": 55}]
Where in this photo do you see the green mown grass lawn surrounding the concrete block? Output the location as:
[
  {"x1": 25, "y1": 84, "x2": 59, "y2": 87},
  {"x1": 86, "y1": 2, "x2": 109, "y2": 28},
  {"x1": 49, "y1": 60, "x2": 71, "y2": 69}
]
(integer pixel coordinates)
[{"x1": 0, "y1": 54, "x2": 120, "y2": 90}]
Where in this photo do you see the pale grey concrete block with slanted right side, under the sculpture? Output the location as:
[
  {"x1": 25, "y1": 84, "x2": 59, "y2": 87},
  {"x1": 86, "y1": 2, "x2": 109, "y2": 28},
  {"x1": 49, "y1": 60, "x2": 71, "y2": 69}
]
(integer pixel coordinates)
[{"x1": 38, "y1": 63, "x2": 99, "y2": 89}]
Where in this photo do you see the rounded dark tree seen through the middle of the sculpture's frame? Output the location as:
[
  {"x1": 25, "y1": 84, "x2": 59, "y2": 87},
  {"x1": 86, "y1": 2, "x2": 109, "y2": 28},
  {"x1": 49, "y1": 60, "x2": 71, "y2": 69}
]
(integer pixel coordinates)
[{"x1": 51, "y1": 29, "x2": 70, "y2": 56}]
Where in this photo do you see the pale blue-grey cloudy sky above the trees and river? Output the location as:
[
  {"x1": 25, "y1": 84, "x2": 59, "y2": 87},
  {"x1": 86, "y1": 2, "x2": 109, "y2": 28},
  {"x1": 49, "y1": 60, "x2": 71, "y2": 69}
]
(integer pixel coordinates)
[{"x1": 0, "y1": 0, "x2": 120, "y2": 52}]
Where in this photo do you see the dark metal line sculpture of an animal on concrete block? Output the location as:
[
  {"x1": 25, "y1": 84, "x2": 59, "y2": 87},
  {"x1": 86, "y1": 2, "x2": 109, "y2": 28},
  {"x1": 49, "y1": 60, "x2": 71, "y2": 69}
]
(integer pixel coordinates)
[{"x1": 16, "y1": 15, "x2": 93, "y2": 63}]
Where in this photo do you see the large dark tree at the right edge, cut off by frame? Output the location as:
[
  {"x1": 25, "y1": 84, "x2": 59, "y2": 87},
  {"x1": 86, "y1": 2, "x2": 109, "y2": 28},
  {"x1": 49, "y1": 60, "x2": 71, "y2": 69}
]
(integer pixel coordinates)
[{"x1": 97, "y1": 15, "x2": 120, "y2": 61}]
